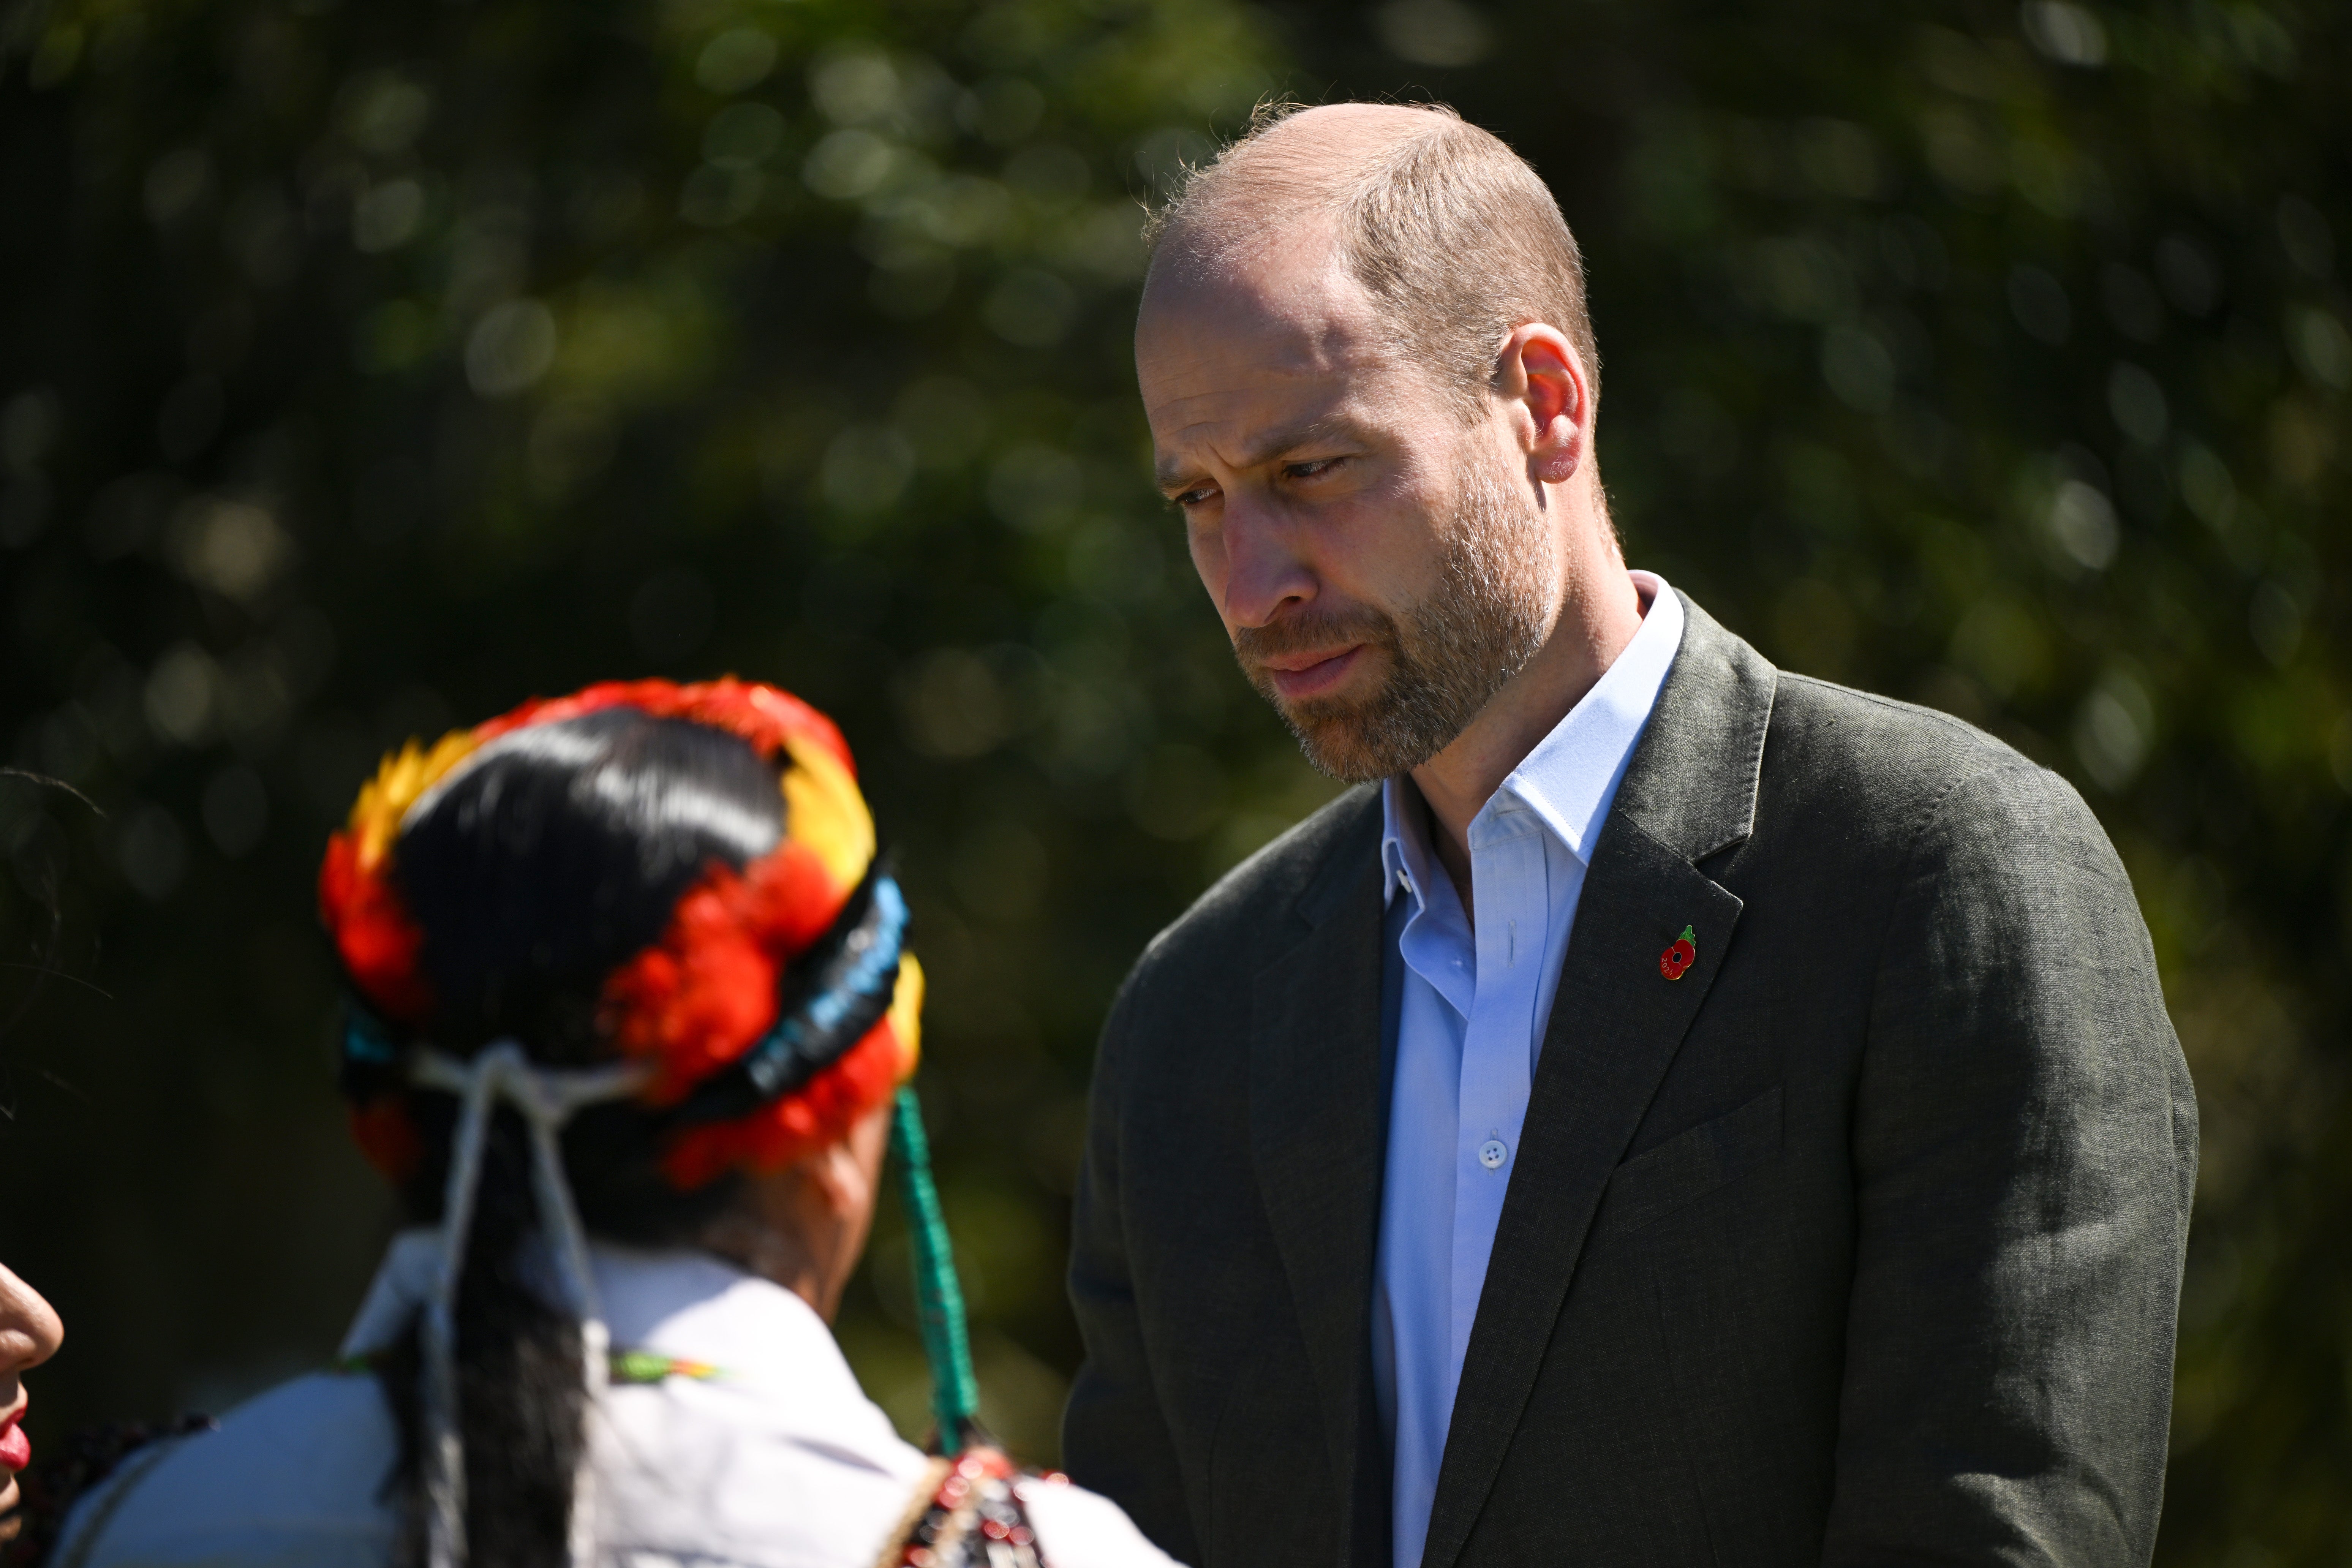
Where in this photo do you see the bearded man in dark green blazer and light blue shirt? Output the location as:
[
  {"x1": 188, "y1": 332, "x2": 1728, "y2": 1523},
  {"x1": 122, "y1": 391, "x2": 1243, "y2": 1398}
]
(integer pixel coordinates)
[{"x1": 1065, "y1": 106, "x2": 2197, "y2": 1568}]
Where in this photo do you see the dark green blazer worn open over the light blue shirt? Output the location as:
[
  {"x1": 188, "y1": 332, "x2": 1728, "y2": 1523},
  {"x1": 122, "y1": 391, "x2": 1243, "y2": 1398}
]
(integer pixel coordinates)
[{"x1": 1065, "y1": 602, "x2": 2197, "y2": 1568}]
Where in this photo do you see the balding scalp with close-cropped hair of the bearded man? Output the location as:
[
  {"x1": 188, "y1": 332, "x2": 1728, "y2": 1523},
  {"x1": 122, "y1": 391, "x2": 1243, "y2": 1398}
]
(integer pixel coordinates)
[{"x1": 1143, "y1": 103, "x2": 1600, "y2": 416}]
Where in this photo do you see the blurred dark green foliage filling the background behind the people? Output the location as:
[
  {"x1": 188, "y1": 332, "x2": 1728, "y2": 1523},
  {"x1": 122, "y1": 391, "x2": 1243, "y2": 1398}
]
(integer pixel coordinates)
[{"x1": 0, "y1": 0, "x2": 2352, "y2": 1563}]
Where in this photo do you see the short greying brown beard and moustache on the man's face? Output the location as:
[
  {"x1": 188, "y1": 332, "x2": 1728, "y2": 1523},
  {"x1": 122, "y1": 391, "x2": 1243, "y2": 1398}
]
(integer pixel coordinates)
[{"x1": 1233, "y1": 458, "x2": 1555, "y2": 783}]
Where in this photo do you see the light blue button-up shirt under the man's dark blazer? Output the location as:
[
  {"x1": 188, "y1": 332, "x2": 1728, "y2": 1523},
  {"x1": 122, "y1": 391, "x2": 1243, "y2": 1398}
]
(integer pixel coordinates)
[{"x1": 1371, "y1": 571, "x2": 1682, "y2": 1568}]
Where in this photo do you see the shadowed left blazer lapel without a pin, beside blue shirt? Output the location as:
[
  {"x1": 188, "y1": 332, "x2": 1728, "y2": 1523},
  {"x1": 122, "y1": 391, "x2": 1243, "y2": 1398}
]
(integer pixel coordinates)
[{"x1": 1249, "y1": 795, "x2": 1388, "y2": 1563}]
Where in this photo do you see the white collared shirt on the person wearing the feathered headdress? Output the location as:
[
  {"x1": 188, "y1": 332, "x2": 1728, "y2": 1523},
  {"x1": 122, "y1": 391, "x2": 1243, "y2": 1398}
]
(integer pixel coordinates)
[{"x1": 52, "y1": 1232, "x2": 1174, "y2": 1568}]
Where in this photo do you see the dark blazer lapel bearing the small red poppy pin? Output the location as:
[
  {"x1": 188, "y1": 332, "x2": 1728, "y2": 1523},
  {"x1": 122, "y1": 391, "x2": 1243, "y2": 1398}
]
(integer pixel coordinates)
[{"x1": 1421, "y1": 599, "x2": 1776, "y2": 1568}]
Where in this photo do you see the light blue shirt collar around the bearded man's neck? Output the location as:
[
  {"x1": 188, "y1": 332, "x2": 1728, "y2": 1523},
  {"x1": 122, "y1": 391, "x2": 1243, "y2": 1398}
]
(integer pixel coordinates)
[{"x1": 1381, "y1": 571, "x2": 1682, "y2": 910}]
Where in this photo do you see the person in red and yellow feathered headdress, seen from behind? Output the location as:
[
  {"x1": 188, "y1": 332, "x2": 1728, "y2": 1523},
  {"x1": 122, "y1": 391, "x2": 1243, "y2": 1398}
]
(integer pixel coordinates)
[{"x1": 54, "y1": 680, "x2": 1195, "y2": 1568}]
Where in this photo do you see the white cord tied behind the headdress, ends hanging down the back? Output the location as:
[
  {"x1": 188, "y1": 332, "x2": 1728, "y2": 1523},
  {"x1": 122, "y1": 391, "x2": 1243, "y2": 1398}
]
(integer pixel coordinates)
[{"x1": 407, "y1": 1039, "x2": 647, "y2": 1568}]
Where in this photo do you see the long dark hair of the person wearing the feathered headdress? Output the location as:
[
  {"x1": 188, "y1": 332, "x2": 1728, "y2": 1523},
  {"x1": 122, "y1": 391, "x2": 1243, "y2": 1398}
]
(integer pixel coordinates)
[{"x1": 355, "y1": 708, "x2": 783, "y2": 1568}]
